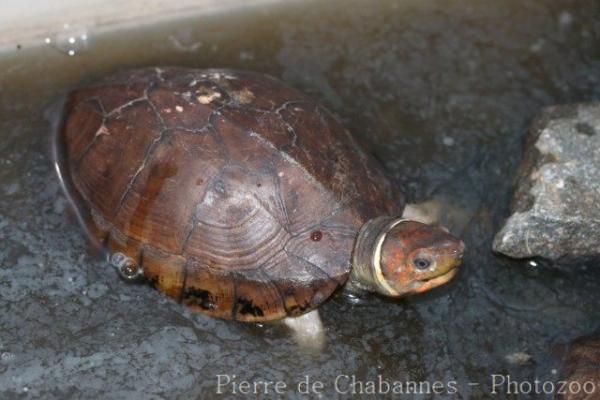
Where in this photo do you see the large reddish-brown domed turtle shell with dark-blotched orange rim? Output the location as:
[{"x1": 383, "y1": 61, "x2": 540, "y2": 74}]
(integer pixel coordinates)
[{"x1": 60, "y1": 68, "x2": 404, "y2": 321}]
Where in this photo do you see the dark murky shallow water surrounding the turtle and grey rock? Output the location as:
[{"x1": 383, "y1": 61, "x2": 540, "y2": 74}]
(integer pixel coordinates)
[{"x1": 0, "y1": 0, "x2": 600, "y2": 399}]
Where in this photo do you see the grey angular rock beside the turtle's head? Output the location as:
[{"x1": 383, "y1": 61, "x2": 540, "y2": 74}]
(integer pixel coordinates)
[{"x1": 493, "y1": 103, "x2": 600, "y2": 262}]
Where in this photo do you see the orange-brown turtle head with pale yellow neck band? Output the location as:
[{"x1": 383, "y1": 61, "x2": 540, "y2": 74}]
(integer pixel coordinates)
[{"x1": 353, "y1": 217, "x2": 465, "y2": 297}]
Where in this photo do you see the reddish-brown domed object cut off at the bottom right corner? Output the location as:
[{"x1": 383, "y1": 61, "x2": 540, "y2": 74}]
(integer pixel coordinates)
[{"x1": 558, "y1": 334, "x2": 600, "y2": 400}]
